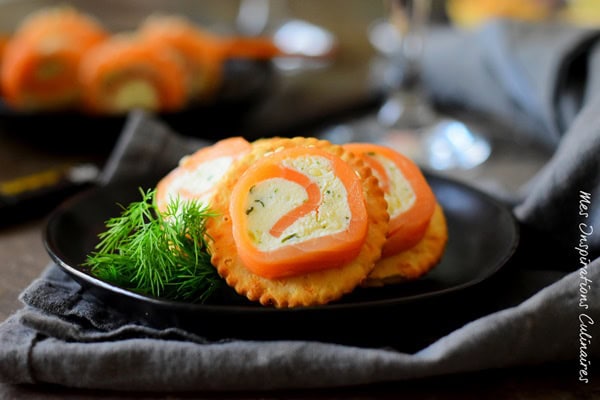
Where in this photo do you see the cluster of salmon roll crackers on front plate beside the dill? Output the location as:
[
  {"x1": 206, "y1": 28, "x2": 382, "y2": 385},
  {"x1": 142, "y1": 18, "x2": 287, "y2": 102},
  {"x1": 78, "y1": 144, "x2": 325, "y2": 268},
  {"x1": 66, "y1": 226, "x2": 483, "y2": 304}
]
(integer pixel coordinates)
[{"x1": 157, "y1": 137, "x2": 447, "y2": 308}]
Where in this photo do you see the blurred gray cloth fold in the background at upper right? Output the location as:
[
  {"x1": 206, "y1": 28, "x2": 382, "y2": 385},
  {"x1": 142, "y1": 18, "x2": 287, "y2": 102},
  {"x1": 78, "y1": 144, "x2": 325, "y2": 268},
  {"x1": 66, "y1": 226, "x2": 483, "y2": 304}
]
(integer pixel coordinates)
[{"x1": 423, "y1": 16, "x2": 600, "y2": 149}]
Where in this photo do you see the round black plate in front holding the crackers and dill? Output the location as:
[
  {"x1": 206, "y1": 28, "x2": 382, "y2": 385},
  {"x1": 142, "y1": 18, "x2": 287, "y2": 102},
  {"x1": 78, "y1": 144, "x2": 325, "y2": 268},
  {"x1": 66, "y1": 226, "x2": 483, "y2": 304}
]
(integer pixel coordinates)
[{"x1": 44, "y1": 176, "x2": 519, "y2": 344}]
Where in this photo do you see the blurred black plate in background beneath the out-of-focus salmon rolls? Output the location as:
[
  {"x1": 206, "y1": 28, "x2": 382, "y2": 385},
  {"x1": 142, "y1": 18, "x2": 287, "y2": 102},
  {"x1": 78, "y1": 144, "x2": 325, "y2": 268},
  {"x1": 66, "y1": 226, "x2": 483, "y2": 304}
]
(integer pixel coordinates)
[{"x1": 0, "y1": 59, "x2": 277, "y2": 152}]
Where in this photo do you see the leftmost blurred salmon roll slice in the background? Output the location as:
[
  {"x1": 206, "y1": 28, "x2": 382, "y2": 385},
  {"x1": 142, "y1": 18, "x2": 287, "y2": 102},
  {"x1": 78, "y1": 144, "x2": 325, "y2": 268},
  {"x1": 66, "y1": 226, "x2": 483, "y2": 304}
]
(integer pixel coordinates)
[{"x1": 0, "y1": 7, "x2": 108, "y2": 111}]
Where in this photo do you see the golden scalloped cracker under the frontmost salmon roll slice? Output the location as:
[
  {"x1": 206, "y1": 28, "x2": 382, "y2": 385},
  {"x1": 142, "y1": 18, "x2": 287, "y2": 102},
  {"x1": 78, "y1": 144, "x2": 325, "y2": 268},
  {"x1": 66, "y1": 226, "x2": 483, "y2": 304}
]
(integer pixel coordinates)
[{"x1": 207, "y1": 138, "x2": 389, "y2": 308}]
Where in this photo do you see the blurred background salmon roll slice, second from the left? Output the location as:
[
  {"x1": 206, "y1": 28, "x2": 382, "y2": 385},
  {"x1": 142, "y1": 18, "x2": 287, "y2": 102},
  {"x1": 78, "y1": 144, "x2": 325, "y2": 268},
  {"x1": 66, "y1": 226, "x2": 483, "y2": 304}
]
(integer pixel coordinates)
[{"x1": 79, "y1": 33, "x2": 187, "y2": 114}]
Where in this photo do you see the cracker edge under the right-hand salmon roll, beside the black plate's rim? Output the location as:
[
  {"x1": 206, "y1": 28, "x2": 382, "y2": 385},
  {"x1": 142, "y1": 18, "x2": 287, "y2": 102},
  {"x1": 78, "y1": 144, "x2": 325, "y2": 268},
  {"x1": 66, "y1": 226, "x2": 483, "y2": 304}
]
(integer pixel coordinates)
[{"x1": 363, "y1": 203, "x2": 448, "y2": 286}]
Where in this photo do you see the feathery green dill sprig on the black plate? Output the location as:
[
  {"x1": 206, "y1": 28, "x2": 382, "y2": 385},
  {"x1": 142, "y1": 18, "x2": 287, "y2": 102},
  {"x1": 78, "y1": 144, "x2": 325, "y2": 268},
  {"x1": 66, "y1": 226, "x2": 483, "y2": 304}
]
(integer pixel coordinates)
[{"x1": 83, "y1": 188, "x2": 222, "y2": 302}]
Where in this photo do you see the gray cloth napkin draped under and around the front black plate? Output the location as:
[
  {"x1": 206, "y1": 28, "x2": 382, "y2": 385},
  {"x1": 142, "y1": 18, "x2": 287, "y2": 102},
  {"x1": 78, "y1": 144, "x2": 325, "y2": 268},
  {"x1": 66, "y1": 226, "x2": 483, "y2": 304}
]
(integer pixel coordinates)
[{"x1": 0, "y1": 19, "x2": 600, "y2": 391}]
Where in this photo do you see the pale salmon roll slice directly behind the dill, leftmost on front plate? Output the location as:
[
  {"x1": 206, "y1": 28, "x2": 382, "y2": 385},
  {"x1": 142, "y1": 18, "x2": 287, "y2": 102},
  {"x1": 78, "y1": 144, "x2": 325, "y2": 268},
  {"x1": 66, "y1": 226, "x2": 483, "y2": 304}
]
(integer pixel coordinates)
[{"x1": 155, "y1": 136, "x2": 251, "y2": 212}]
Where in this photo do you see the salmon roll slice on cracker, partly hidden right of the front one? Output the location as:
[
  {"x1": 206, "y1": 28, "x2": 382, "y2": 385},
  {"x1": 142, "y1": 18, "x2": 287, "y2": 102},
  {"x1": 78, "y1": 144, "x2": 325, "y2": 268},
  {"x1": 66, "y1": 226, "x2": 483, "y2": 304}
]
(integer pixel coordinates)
[{"x1": 344, "y1": 143, "x2": 447, "y2": 285}]
